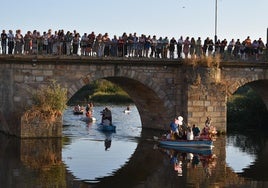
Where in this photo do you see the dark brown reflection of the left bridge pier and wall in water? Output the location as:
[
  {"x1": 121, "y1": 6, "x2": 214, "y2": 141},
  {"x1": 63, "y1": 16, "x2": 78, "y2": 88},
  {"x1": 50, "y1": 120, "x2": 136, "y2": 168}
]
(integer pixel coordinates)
[{"x1": 0, "y1": 134, "x2": 66, "y2": 188}]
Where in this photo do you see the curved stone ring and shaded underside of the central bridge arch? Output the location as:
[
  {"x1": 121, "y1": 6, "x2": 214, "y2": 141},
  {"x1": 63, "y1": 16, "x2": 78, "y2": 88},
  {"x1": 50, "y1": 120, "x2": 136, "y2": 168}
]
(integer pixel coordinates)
[{"x1": 68, "y1": 70, "x2": 174, "y2": 129}]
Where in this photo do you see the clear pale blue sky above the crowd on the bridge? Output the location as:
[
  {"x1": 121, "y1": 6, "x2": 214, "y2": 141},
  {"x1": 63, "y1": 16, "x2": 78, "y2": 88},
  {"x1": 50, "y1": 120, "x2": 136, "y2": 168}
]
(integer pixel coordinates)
[{"x1": 0, "y1": 0, "x2": 268, "y2": 43}]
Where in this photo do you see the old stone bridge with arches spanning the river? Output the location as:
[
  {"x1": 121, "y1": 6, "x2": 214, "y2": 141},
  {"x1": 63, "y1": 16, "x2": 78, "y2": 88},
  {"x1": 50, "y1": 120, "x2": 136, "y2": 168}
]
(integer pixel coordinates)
[{"x1": 0, "y1": 56, "x2": 268, "y2": 137}]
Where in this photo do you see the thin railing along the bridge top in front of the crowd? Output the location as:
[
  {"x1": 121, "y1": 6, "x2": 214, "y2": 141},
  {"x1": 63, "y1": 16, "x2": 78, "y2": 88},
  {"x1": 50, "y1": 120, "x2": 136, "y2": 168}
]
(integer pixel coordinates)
[{"x1": 0, "y1": 48, "x2": 268, "y2": 63}]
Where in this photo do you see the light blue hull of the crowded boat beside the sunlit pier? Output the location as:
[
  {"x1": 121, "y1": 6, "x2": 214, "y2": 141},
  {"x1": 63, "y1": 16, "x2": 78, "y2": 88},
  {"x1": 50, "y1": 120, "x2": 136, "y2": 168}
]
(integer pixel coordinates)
[{"x1": 159, "y1": 139, "x2": 213, "y2": 149}]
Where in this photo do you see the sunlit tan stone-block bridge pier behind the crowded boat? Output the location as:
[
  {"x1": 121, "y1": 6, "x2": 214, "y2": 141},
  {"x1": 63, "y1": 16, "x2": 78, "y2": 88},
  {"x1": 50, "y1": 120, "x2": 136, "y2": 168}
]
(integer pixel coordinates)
[{"x1": 184, "y1": 67, "x2": 227, "y2": 132}]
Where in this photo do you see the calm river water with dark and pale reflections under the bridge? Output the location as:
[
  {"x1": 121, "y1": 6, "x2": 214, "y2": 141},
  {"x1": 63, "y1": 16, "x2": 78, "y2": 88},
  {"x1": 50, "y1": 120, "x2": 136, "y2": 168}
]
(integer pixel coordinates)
[{"x1": 0, "y1": 106, "x2": 268, "y2": 188}]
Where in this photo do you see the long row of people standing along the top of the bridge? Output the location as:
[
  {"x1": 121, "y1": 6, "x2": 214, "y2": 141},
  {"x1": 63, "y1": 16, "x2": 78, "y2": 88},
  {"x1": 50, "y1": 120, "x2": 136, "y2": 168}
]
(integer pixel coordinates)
[{"x1": 0, "y1": 29, "x2": 267, "y2": 60}]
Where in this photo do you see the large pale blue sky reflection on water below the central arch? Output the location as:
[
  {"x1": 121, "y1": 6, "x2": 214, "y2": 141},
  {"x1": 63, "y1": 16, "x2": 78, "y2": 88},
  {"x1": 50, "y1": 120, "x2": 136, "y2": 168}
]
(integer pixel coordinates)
[{"x1": 62, "y1": 138, "x2": 137, "y2": 182}]
